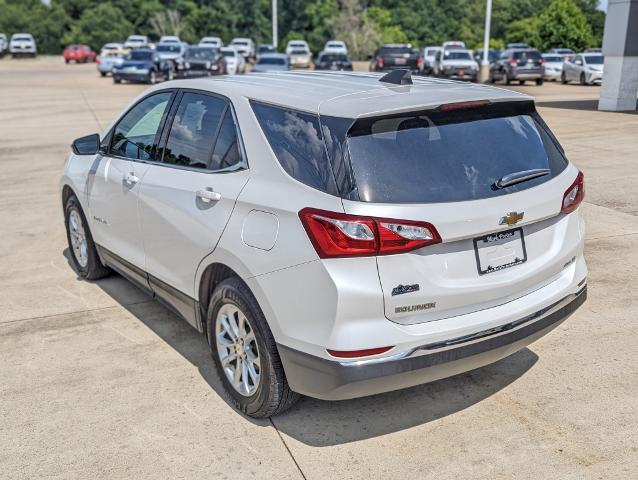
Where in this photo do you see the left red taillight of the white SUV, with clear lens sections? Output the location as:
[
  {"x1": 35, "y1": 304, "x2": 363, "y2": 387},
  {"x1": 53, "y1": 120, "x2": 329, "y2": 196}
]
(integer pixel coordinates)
[{"x1": 299, "y1": 208, "x2": 441, "y2": 258}]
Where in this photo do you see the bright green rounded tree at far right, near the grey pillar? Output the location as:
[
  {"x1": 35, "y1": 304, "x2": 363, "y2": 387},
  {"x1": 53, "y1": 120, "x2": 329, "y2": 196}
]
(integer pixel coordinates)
[{"x1": 538, "y1": 0, "x2": 594, "y2": 51}]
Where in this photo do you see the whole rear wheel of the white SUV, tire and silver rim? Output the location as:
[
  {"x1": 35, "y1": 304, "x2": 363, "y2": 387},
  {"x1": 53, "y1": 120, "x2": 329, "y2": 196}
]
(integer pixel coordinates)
[{"x1": 206, "y1": 277, "x2": 299, "y2": 418}]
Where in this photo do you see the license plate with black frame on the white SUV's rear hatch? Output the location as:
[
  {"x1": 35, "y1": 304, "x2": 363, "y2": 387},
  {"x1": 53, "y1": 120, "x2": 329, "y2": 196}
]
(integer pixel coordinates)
[{"x1": 474, "y1": 228, "x2": 527, "y2": 275}]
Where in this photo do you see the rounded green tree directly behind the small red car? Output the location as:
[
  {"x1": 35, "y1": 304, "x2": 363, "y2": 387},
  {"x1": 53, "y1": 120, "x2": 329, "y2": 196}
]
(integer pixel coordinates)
[{"x1": 63, "y1": 3, "x2": 133, "y2": 51}]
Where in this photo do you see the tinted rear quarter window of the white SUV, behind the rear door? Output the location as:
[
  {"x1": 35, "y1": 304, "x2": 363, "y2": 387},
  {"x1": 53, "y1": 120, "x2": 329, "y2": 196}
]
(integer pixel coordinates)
[{"x1": 251, "y1": 102, "x2": 338, "y2": 195}]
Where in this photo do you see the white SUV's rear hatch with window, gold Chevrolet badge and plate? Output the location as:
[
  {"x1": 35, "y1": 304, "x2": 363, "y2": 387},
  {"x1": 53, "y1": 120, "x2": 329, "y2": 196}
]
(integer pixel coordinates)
[{"x1": 328, "y1": 101, "x2": 580, "y2": 324}]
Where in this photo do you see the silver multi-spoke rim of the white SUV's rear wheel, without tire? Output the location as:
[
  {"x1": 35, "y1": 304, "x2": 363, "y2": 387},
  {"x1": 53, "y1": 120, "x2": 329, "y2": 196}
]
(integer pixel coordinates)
[{"x1": 215, "y1": 303, "x2": 261, "y2": 397}]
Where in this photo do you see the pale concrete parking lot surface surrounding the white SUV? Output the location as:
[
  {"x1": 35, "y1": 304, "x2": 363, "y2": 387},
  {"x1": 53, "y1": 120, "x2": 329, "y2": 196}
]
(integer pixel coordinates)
[{"x1": 0, "y1": 57, "x2": 638, "y2": 480}]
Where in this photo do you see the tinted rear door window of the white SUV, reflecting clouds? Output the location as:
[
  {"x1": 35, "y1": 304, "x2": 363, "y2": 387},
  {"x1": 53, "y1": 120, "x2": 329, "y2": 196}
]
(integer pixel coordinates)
[{"x1": 162, "y1": 93, "x2": 226, "y2": 168}]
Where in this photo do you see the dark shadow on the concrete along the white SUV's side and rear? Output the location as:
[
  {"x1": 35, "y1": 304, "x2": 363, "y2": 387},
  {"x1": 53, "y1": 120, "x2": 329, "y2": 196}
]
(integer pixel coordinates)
[{"x1": 80, "y1": 255, "x2": 538, "y2": 447}]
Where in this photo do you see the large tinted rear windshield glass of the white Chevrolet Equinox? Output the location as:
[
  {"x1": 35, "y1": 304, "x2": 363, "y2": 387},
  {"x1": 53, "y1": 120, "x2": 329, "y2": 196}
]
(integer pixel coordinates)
[{"x1": 346, "y1": 102, "x2": 567, "y2": 203}]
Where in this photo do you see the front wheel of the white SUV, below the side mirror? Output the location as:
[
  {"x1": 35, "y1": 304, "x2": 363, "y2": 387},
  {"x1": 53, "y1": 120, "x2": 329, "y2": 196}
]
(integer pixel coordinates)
[{"x1": 64, "y1": 195, "x2": 110, "y2": 280}]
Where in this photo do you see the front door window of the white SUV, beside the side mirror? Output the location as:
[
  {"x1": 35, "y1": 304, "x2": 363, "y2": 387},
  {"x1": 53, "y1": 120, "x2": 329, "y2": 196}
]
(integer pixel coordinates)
[{"x1": 111, "y1": 92, "x2": 172, "y2": 160}]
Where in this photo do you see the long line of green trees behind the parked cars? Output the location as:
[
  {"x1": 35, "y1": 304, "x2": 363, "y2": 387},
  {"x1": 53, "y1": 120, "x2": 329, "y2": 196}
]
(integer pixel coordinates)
[{"x1": 0, "y1": 0, "x2": 605, "y2": 59}]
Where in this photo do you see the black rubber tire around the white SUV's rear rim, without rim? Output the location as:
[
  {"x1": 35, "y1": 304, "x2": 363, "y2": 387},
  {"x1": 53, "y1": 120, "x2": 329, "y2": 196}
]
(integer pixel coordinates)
[{"x1": 206, "y1": 277, "x2": 300, "y2": 418}]
